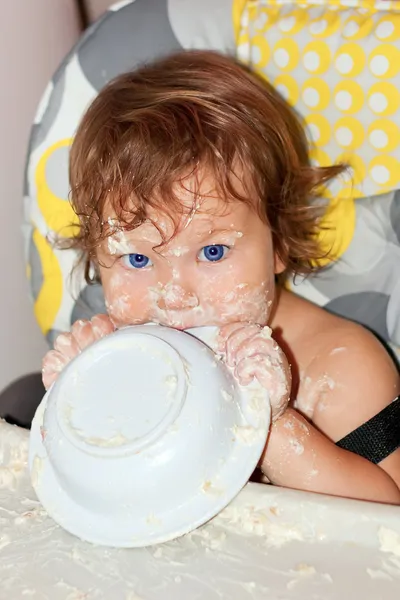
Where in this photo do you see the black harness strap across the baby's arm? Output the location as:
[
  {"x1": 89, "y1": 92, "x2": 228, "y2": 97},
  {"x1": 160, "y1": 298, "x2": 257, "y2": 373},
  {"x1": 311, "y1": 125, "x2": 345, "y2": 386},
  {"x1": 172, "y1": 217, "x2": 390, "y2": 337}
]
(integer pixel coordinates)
[{"x1": 336, "y1": 396, "x2": 400, "y2": 464}]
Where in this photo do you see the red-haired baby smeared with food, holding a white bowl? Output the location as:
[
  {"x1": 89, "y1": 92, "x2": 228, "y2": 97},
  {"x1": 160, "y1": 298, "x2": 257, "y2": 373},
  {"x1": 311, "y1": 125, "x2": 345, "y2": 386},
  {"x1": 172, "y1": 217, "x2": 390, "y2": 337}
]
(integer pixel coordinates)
[{"x1": 43, "y1": 52, "x2": 400, "y2": 504}]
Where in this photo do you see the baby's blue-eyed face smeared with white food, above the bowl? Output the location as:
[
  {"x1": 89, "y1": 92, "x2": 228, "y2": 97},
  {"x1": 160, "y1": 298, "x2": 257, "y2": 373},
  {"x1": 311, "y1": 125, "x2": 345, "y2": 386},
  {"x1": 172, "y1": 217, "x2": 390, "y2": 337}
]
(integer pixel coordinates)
[{"x1": 98, "y1": 171, "x2": 276, "y2": 329}]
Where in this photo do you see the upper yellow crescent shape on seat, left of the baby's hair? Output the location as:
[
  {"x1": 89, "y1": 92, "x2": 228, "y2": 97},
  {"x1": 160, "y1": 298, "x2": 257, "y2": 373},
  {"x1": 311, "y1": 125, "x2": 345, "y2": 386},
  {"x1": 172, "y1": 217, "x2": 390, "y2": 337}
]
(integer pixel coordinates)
[{"x1": 35, "y1": 139, "x2": 79, "y2": 237}]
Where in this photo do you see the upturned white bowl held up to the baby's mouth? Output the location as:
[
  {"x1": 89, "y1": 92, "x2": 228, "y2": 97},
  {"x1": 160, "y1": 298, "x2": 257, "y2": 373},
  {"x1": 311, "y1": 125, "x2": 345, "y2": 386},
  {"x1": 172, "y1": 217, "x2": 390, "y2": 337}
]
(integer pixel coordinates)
[{"x1": 29, "y1": 325, "x2": 270, "y2": 547}]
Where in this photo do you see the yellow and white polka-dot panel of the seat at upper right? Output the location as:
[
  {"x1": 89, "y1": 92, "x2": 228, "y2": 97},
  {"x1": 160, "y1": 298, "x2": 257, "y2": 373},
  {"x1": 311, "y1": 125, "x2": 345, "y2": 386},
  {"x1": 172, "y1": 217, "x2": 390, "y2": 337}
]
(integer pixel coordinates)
[{"x1": 238, "y1": 0, "x2": 400, "y2": 197}]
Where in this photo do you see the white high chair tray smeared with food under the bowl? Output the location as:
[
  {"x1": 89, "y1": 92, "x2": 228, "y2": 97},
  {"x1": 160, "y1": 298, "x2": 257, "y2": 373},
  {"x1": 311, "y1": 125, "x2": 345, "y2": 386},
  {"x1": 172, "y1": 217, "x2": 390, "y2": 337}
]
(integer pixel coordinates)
[{"x1": 0, "y1": 421, "x2": 400, "y2": 600}]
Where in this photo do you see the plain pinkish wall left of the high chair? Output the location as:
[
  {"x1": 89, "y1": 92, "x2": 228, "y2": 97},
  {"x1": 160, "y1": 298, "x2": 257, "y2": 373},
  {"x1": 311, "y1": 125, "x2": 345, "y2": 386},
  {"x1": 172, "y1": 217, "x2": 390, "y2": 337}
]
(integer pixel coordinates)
[{"x1": 0, "y1": 0, "x2": 79, "y2": 390}]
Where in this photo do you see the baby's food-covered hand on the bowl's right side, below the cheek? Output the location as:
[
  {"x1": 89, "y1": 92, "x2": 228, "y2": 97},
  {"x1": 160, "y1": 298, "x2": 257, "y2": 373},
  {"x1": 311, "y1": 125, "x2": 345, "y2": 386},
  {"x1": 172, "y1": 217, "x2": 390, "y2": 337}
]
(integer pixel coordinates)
[{"x1": 218, "y1": 323, "x2": 292, "y2": 421}]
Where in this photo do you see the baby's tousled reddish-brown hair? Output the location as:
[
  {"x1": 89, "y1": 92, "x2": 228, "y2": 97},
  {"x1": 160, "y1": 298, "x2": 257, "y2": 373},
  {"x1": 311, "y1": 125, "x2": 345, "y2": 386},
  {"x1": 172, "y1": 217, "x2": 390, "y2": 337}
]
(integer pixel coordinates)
[{"x1": 70, "y1": 51, "x2": 343, "y2": 282}]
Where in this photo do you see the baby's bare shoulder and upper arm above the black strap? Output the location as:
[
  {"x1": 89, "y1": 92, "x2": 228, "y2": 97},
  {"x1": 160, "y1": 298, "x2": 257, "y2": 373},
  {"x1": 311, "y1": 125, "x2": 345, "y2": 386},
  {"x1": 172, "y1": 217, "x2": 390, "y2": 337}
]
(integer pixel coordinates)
[{"x1": 273, "y1": 292, "x2": 400, "y2": 434}]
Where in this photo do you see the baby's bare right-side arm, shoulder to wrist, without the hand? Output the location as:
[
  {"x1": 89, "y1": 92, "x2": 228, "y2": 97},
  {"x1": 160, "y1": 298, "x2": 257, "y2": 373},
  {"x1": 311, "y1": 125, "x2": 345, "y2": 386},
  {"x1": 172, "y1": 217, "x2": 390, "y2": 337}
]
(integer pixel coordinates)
[{"x1": 262, "y1": 327, "x2": 400, "y2": 504}]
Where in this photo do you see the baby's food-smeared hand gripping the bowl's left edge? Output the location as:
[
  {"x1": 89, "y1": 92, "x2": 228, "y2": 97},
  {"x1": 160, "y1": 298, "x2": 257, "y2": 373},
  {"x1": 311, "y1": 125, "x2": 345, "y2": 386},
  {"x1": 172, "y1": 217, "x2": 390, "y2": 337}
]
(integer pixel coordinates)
[{"x1": 42, "y1": 315, "x2": 115, "y2": 390}]
